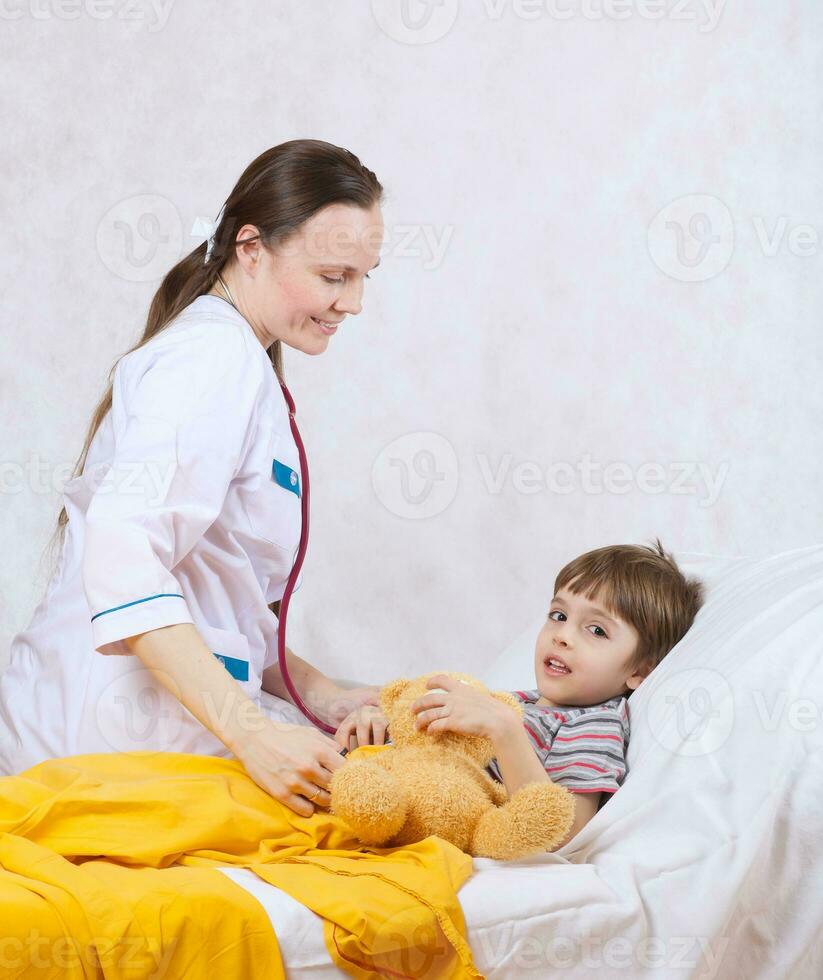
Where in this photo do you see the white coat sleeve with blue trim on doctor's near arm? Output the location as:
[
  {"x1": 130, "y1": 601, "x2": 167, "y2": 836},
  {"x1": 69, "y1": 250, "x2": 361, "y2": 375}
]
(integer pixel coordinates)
[{"x1": 82, "y1": 321, "x2": 265, "y2": 654}]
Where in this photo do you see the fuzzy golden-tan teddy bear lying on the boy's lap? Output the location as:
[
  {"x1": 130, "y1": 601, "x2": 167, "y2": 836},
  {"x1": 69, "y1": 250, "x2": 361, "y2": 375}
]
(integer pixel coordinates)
[{"x1": 330, "y1": 671, "x2": 574, "y2": 860}]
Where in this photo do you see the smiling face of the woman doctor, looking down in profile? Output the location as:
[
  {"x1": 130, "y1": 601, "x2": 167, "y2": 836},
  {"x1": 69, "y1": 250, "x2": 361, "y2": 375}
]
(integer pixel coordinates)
[{"x1": 227, "y1": 204, "x2": 384, "y2": 354}]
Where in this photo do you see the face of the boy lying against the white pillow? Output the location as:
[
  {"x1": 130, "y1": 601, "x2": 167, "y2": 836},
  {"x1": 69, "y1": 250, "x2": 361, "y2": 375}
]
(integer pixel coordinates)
[{"x1": 534, "y1": 583, "x2": 648, "y2": 706}]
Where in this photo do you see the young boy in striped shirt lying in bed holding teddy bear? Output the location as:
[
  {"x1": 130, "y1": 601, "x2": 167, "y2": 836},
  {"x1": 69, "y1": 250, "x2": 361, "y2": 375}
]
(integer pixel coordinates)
[{"x1": 336, "y1": 538, "x2": 704, "y2": 847}]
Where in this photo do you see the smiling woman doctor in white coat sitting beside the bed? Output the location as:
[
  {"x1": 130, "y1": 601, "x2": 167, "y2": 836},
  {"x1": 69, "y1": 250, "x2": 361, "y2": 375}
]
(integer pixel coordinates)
[{"x1": 0, "y1": 140, "x2": 383, "y2": 816}]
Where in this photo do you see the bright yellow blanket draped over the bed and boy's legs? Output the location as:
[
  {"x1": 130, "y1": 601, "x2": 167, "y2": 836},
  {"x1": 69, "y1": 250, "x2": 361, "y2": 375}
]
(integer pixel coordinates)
[{"x1": 0, "y1": 746, "x2": 482, "y2": 980}]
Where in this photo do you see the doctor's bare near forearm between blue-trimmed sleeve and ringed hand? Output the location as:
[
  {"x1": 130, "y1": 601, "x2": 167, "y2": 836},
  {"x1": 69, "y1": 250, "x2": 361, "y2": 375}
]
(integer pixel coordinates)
[{"x1": 125, "y1": 623, "x2": 271, "y2": 755}]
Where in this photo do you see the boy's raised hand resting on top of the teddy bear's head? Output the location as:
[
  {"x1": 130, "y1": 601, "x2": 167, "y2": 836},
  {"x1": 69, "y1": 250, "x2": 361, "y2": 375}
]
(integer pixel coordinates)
[{"x1": 411, "y1": 674, "x2": 512, "y2": 739}]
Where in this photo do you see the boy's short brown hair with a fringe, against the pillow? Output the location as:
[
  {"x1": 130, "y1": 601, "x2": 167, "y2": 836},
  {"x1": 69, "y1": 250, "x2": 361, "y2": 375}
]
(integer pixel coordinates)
[{"x1": 554, "y1": 538, "x2": 705, "y2": 671}]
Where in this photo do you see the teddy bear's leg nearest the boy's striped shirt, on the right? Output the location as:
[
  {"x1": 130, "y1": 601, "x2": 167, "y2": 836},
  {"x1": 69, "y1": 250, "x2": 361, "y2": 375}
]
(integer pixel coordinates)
[{"x1": 471, "y1": 782, "x2": 574, "y2": 861}]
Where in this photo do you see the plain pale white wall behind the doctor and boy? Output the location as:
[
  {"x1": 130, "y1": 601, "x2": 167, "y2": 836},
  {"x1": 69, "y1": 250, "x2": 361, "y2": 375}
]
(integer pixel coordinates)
[{"x1": 0, "y1": 0, "x2": 823, "y2": 683}]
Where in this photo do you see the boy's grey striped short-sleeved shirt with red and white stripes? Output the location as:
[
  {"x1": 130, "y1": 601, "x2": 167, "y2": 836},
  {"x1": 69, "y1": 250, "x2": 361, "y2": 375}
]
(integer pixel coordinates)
[{"x1": 487, "y1": 691, "x2": 629, "y2": 803}]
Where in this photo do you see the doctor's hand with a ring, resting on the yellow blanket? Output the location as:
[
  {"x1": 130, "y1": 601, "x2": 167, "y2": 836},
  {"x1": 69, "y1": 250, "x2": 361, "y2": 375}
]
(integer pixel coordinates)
[{"x1": 234, "y1": 719, "x2": 345, "y2": 817}]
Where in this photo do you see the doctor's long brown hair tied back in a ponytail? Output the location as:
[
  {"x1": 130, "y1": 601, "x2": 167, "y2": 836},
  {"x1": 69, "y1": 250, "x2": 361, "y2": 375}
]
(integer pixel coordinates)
[{"x1": 52, "y1": 140, "x2": 383, "y2": 564}]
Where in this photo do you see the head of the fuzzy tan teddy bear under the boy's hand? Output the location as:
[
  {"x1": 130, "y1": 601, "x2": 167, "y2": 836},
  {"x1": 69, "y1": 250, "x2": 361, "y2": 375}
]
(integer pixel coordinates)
[{"x1": 380, "y1": 670, "x2": 523, "y2": 767}]
